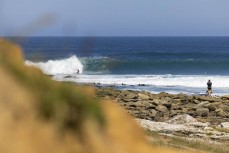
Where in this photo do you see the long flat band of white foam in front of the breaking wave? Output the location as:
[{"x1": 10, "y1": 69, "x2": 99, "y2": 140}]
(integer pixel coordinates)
[{"x1": 56, "y1": 75, "x2": 229, "y2": 88}]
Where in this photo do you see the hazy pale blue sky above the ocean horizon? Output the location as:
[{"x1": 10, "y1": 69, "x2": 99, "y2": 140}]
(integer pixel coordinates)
[{"x1": 0, "y1": 0, "x2": 229, "y2": 36}]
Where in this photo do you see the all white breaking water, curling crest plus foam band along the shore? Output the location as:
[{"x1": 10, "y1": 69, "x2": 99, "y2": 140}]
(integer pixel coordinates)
[{"x1": 25, "y1": 55, "x2": 229, "y2": 95}]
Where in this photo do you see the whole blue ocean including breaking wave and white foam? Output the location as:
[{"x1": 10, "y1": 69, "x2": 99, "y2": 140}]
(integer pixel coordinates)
[{"x1": 10, "y1": 37, "x2": 229, "y2": 95}]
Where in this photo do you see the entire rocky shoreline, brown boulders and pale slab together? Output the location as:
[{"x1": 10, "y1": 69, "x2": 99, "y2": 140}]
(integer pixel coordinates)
[{"x1": 96, "y1": 87, "x2": 229, "y2": 141}]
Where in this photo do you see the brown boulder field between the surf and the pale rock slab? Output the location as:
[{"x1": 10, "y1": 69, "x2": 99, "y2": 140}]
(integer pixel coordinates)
[{"x1": 97, "y1": 88, "x2": 229, "y2": 125}]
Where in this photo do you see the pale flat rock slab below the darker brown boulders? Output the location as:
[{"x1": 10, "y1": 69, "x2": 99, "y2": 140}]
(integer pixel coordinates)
[{"x1": 136, "y1": 114, "x2": 229, "y2": 141}]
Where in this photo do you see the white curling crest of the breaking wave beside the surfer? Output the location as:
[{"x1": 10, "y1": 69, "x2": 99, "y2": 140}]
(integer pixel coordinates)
[{"x1": 25, "y1": 56, "x2": 83, "y2": 75}]
